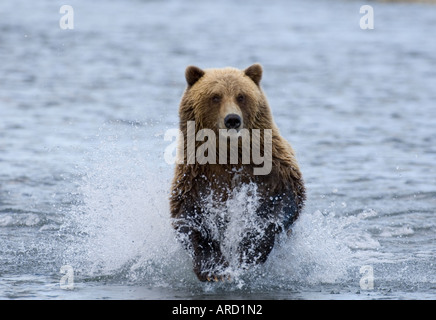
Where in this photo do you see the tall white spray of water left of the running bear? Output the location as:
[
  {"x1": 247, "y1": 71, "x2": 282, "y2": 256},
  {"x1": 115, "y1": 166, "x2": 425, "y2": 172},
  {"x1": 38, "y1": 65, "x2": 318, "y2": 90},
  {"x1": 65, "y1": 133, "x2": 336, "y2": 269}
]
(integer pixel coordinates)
[{"x1": 62, "y1": 131, "x2": 189, "y2": 279}]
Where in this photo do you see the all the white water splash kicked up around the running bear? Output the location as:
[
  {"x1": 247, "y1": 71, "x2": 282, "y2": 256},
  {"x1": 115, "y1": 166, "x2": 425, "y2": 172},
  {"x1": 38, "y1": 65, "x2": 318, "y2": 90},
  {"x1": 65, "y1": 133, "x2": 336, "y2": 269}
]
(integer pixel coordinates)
[{"x1": 60, "y1": 126, "x2": 380, "y2": 291}]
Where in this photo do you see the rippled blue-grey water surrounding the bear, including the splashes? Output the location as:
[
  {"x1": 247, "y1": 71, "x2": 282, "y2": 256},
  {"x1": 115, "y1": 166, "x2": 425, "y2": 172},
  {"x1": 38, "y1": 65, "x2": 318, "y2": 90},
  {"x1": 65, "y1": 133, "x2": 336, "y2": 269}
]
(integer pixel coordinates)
[{"x1": 0, "y1": 0, "x2": 436, "y2": 299}]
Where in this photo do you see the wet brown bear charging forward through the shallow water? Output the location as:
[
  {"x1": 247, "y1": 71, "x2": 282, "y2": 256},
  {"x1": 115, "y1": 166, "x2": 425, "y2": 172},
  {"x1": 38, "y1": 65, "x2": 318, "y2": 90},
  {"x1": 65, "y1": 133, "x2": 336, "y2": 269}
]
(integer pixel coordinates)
[{"x1": 170, "y1": 64, "x2": 305, "y2": 281}]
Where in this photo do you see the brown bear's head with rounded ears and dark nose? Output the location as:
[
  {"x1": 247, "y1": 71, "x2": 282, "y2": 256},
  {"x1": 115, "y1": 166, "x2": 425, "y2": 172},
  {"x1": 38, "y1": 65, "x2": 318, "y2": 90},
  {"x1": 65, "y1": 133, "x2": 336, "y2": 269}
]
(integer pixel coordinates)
[{"x1": 179, "y1": 64, "x2": 273, "y2": 132}]
